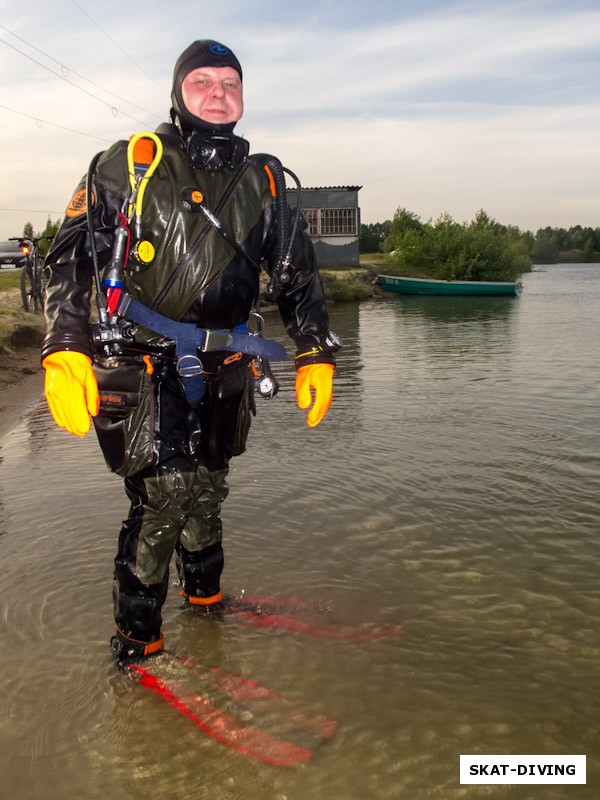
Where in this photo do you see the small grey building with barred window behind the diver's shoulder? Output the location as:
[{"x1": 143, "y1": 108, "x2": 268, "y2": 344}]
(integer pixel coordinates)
[{"x1": 287, "y1": 186, "x2": 362, "y2": 267}]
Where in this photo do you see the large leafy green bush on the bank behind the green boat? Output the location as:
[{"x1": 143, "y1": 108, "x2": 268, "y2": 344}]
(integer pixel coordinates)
[{"x1": 385, "y1": 209, "x2": 531, "y2": 281}]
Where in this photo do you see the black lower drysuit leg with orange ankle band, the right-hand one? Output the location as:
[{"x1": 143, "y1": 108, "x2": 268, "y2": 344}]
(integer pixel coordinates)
[{"x1": 176, "y1": 542, "x2": 224, "y2": 608}]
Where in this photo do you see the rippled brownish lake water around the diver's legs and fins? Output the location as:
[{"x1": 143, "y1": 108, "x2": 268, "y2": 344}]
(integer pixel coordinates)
[{"x1": 0, "y1": 265, "x2": 600, "y2": 800}]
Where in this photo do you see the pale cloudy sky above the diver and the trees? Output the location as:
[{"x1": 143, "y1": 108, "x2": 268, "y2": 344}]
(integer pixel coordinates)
[{"x1": 0, "y1": 0, "x2": 600, "y2": 239}]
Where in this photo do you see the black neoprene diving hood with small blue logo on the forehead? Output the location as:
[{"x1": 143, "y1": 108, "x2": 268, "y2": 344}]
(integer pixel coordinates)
[{"x1": 171, "y1": 39, "x2": 243, "y2": 131}]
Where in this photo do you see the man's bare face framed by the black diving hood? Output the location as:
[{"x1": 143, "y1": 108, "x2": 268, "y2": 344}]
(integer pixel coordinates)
[{"x1": 181, "y1": 67, "x2": 244, "y2": 125}]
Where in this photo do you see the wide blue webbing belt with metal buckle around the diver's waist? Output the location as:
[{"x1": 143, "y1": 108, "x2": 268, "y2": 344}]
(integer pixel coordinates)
[{"x1": 116, "y1": 292, "x2": 287, "y2": 403}]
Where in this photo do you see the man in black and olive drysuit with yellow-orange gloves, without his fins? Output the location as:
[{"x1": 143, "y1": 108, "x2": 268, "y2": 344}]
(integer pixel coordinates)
[{"x1": 42, "y1": 40, "x2": 339, "y2": 659}]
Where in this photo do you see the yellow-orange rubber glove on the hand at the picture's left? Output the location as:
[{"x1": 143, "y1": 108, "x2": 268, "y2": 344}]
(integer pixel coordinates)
[{"x1": 42, "y1": 350, "x2": 100, "y2": 436}]
